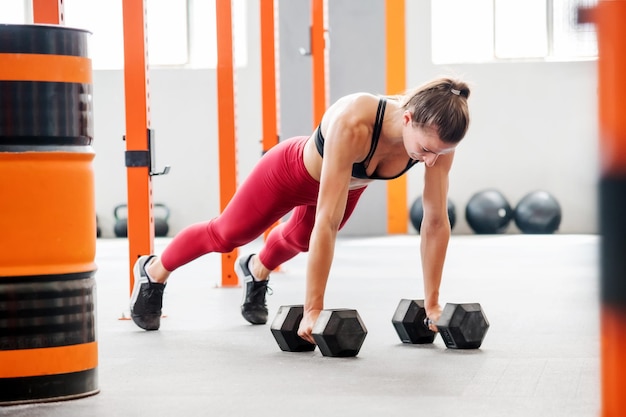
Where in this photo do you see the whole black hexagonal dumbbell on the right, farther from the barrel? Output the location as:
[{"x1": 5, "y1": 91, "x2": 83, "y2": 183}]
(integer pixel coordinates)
[{"x1": 391, "y1": 299, "x2": 489, "y2": 349}]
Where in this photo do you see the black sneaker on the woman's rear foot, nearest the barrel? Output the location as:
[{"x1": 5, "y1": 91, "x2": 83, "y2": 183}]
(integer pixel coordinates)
[{"x1": 130, "y1": 255, "x2": 165, "y2": 330}]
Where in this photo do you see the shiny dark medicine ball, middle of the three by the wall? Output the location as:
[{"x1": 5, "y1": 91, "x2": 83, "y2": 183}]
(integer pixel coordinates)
[{"x1": 465, "y1": 189, "x2": 513, "y2": 234}]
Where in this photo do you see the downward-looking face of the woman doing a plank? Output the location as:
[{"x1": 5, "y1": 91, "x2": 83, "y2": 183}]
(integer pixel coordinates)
[{"x1": 402, "y1": 110, "x2": 457, "y2": 167}]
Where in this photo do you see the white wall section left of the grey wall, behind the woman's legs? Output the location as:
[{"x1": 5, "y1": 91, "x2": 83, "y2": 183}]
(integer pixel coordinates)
[{"x1": 93, "y1": 2, "x2": 262, "y2": 237}]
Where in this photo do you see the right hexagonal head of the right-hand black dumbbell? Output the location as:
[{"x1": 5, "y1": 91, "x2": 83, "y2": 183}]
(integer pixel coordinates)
[{"x1": 436, "y1": 303, "x2": 489, "y2": 349}]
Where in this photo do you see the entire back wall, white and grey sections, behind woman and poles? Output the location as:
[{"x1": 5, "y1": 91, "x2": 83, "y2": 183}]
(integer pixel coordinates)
[{"x1": 94, "y1": 0, "x2": 598, "y2": 236}]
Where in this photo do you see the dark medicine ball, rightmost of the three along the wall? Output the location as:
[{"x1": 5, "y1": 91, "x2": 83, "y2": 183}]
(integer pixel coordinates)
[{"x1": 515, "y1": 191, "x2": 561, "y2": 234}]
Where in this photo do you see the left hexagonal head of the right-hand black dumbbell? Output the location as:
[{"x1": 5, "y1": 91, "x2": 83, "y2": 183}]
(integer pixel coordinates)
[{"x1": 391, "y1": 299, "x2": 437, "y2": 344}]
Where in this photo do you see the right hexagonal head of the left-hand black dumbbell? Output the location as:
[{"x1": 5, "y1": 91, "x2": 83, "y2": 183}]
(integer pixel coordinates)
[{"x1": 313, "y1": 309, "x2": 367, "y2": 357}]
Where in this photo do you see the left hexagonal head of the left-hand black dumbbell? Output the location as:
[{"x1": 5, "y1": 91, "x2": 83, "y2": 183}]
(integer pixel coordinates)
[{"x1": 270, "y1": 305, "x2": 315, "y2": 352}]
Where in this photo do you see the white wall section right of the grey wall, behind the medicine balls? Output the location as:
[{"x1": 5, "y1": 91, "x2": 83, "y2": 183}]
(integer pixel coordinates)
[{"x1": 406, "y1": 1, "x2": 598, "y2": 233}]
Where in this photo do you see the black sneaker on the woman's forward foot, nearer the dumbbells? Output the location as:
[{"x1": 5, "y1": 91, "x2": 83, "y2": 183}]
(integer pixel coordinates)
[{"x1": 235, "y1": 254, "x2": 271, "y2": 324}]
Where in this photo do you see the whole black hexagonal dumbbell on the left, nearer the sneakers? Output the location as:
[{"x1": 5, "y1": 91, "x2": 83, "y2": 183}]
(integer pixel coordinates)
[{"x1": 270, "y1": 305, "x2": 367, "y2": 357}]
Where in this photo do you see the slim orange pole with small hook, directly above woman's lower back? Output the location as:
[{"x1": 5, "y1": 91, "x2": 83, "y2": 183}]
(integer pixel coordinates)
[{"x1": 311, "y1": 0, "x2": 327, "y2": 129}]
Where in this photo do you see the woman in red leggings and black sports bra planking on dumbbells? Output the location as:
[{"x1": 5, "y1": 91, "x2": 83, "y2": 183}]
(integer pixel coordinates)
[{"x1": 131, "y1": 78, "x2": 470, "y2": 343}]
